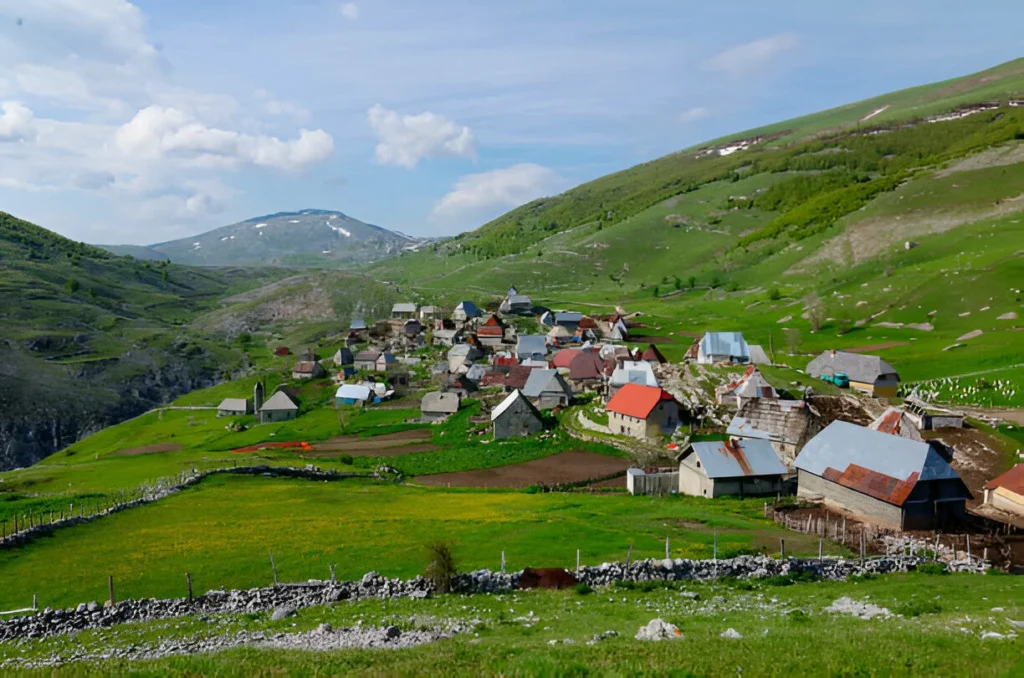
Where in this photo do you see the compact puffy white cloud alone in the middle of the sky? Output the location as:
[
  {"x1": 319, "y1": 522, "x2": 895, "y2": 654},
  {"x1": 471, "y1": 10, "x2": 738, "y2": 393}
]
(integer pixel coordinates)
[{"x1": 367, "y1": 103, "x2": 476, "y2": 169}]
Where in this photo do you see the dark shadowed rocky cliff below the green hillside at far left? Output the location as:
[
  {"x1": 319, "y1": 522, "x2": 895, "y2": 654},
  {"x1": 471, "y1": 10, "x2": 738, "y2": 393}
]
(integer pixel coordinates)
[{"x1": 0, "y1": 341, "x2": 241, "y2": 471}]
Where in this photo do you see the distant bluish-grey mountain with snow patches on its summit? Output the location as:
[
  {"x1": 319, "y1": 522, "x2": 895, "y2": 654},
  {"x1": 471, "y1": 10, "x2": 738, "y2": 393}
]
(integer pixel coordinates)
[{"x1": 100, "y1": 210, "x2": 430, "y2": 267}]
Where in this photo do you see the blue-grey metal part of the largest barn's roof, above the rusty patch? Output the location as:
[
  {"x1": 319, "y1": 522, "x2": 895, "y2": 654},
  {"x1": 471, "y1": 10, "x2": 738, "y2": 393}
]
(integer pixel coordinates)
[{"x1": 794, "y1": 421, "x2": 959, "y2": 482}]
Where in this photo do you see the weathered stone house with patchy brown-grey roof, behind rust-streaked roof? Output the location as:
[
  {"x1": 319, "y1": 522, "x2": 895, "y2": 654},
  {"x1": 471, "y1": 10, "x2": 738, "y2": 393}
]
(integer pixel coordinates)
[{"x1": 726, "y1": 398, "x2": 821, "y2": 467}]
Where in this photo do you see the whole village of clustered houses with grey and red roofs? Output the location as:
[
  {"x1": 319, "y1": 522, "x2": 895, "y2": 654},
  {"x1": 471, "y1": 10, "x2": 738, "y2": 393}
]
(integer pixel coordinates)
[{"x1": 211, "y1": 288, "x2": 1024, "y2": 529}]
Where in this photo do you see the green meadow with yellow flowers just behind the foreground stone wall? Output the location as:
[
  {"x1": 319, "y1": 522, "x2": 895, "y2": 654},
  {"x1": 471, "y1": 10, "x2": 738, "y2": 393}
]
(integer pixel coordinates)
[{"x1": 0, "y1": 476, "x2": 838, "y2": 609}]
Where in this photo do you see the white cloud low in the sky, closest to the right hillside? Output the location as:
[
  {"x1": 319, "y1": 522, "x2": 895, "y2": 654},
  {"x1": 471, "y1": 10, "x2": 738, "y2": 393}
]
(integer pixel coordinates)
[{"x1": 431, "y1": 163, "x2": 565, "y2": 225}]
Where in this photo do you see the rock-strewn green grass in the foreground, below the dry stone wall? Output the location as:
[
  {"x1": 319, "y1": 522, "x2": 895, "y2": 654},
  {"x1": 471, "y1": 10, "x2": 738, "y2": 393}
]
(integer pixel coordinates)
[{"x1": 0, "y1": 575, "x2": 1024, "y2": 676}]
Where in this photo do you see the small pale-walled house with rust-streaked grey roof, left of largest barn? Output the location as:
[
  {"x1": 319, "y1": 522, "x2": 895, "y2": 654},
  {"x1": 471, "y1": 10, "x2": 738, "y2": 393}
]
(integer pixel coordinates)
[{"x1": 679, "y1": 438, "x2": 787, "y2": 499}]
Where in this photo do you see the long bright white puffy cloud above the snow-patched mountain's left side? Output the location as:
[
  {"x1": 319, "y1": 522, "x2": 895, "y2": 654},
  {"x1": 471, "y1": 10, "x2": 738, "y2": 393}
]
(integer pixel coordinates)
[{"x1": 115, "y1": 105, "x2": 334, "y2": 170}]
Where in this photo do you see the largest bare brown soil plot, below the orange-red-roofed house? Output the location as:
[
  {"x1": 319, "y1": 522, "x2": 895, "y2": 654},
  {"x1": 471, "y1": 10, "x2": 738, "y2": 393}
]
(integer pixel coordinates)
[{"x1": 416, "y1": 451, "x2": 633, "y2": 488}]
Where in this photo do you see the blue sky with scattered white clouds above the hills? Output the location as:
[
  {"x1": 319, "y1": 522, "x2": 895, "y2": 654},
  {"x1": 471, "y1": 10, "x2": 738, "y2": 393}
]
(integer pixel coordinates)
[{"x1": 0, "y1": 0, "x2": 1024, "y2": 245}]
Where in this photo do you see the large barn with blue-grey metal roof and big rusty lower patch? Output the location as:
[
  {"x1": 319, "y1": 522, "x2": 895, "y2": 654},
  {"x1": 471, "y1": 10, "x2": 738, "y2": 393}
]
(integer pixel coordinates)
[{"x1": 794, "y1": 421, "x2": 970, "y2": 529}]
